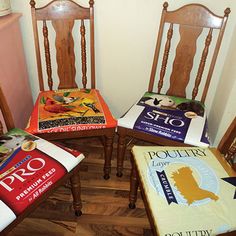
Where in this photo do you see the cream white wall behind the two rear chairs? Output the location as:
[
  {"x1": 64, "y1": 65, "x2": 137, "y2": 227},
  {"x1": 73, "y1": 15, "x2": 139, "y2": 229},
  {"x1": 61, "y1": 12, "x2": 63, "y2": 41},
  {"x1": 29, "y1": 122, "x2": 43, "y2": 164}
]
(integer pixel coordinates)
[{"x1": 11, "y1": 0, "x2": 236, "y2": 145}]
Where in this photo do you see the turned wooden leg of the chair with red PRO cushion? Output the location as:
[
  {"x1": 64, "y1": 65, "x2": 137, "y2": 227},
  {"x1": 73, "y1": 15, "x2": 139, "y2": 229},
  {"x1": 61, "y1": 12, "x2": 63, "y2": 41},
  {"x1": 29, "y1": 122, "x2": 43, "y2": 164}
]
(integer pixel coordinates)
[{"x1": 70, "y1": 171, "x2": 82, "y2": 216}]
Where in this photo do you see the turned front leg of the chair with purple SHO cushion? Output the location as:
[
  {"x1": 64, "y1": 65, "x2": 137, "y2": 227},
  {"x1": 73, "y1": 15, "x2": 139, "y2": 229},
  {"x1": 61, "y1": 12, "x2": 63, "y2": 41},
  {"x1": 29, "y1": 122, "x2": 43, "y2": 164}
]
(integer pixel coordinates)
[{"x1": 116, "y1": 134, "x2": 126, "y2": 177}]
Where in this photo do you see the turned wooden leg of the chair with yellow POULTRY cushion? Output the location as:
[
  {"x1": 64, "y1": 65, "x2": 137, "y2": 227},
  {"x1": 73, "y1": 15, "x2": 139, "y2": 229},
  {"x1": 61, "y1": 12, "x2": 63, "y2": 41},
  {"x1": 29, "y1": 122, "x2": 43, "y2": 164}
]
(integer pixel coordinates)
[{"x1": 129, "y1": 158, "x2": 139, "y2": 209}]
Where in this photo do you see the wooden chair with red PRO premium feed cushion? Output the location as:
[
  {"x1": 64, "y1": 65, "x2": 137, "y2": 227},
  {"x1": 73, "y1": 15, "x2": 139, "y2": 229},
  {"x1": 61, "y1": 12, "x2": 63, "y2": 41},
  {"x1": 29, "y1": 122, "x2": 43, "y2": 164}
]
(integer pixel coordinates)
[{"x1": 0, "y1": 87, "x2": 84, "y2": 235}]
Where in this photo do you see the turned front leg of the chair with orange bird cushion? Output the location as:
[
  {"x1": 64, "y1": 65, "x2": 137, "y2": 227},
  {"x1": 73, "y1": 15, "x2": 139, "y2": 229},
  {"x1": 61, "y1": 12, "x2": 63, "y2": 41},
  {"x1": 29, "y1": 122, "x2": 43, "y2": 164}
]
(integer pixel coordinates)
[{"x1": 103, "y1": 136, "x2": 113, "y2": 180}]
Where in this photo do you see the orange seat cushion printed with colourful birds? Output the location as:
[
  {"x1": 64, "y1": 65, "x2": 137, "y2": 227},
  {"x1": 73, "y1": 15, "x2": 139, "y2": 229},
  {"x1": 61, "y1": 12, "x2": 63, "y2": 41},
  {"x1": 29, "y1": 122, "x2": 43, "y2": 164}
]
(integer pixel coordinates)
[{"x1": 26, "y1": 89, "x2": 117, "y2": 134}]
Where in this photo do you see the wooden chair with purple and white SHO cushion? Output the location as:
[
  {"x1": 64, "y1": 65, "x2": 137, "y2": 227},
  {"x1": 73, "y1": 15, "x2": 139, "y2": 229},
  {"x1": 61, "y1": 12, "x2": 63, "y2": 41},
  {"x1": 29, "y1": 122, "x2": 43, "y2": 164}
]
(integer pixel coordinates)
[{"x1": 117, "y1": 2, "x2": 230, "y2": 176}]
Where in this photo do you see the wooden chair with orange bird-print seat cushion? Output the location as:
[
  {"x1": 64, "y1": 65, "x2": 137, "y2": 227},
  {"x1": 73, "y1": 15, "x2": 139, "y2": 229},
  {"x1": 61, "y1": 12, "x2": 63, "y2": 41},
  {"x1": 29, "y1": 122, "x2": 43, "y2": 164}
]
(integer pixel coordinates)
[{"x1": 26, "y1": 0, "x2": 117, "y2": 179}]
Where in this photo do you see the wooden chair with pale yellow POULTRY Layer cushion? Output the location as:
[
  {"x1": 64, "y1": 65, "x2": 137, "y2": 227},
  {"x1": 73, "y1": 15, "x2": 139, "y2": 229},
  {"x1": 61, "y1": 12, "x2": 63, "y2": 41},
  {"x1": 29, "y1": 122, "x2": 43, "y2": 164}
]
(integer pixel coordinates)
[{"x1": 129, "y1": 118, "x2": 236, "y2": 236}]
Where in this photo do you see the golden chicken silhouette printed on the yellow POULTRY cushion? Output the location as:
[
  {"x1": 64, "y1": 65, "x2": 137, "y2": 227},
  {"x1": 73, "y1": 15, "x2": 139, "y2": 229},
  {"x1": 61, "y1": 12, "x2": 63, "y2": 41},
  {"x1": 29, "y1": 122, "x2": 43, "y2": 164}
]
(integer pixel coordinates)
[{"x1": 171, "y1": 167, "x2": 219, "y2": 205}]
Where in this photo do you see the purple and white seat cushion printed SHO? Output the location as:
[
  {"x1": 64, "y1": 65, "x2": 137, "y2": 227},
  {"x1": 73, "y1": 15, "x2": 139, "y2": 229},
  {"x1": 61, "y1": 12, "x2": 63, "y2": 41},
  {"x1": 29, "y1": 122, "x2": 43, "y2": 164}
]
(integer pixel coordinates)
[{"x1": 118, "y1": 92, "x2": 209, "y2": 147}]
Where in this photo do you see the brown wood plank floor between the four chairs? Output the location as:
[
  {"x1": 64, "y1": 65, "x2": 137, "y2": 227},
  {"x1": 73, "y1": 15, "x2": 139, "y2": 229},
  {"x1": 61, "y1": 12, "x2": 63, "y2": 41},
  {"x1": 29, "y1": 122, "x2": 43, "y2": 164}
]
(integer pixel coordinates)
[{"x1": 9, "y1": 138, "x2": 152, "y2": 236}]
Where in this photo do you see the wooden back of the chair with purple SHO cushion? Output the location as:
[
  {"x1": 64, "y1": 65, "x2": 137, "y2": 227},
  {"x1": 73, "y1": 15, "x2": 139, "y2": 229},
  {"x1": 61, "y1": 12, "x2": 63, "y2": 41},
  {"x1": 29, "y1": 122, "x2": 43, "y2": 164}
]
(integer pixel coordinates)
[{"x1": 148, "y1": 2, "x2": 230, "y2": 102}]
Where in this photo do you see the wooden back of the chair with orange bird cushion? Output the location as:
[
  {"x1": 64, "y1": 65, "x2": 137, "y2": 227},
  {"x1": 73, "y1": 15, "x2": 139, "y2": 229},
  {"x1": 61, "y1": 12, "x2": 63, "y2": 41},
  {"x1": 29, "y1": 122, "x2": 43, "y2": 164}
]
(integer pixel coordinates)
[{"x1": 30, "y1": 0, "x2": 95, "y2": 91}]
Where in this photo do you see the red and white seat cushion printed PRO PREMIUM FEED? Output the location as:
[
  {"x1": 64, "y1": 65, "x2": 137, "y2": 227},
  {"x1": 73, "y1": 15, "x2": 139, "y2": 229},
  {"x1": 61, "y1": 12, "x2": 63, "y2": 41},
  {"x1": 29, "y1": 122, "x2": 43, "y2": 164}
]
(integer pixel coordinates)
[{"x1": 0, "y1": 129, "x2": 84, "y2": 231}]
